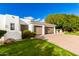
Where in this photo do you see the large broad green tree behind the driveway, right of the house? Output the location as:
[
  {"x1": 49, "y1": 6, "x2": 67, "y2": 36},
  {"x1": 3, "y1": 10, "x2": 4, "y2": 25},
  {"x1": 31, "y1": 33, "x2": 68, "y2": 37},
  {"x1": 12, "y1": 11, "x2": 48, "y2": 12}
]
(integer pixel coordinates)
[{"x1": 45, "y1": 14, "x2": 79, "y2": 32}]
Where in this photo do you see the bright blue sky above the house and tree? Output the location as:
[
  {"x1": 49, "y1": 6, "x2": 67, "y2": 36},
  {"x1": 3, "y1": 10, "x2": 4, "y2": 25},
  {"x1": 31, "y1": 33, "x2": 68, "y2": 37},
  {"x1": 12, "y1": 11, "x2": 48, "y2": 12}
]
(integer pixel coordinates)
[{"x1": 0, "y1": 3, "x2": 79, "y2": 21}]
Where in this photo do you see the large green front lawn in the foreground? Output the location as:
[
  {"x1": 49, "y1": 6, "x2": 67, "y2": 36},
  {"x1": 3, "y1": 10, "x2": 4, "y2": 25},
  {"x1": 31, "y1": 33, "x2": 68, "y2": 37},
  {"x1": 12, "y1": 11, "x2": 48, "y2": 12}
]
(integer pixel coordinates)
[{"x1": 0, "y1": 39, "x2": 76, "y2": 56}]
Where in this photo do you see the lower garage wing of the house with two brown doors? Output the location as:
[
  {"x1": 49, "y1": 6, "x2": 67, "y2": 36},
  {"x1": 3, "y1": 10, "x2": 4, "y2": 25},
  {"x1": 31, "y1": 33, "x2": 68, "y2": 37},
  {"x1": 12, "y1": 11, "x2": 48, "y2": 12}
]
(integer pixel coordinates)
[{"x1": 20, "y1": 18, "x2": 56, "y2": 35}]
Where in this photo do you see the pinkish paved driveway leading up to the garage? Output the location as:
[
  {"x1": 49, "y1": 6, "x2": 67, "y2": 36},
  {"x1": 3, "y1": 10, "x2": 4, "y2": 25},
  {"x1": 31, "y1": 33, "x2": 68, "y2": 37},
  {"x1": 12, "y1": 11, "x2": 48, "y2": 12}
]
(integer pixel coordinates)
[{"x1": 44, "y1": 34, "x2": 79, "y2": 55}]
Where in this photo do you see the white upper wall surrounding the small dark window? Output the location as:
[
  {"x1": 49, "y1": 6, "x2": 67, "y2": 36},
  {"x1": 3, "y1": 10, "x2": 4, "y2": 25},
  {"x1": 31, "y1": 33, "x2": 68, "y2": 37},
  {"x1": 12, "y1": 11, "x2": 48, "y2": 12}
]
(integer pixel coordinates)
[{"x1": 0, "y1": 15, "x2": 20, "y2": 31}]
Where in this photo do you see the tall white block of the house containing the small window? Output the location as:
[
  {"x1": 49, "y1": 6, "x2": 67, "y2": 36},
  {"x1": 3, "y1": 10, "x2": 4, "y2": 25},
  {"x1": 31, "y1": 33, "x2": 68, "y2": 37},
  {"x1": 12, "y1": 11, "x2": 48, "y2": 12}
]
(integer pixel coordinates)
[{"x1": 0, "y1": 14, "x2": 21, "y2": 40}]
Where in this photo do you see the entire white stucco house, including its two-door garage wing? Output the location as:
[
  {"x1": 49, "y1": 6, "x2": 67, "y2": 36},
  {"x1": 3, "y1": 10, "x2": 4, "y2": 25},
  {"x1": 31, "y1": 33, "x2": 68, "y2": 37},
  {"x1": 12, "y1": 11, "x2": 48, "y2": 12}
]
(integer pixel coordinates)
[{"x1": 0, "y1": 14, "x2": 56, "y2": 41}]
